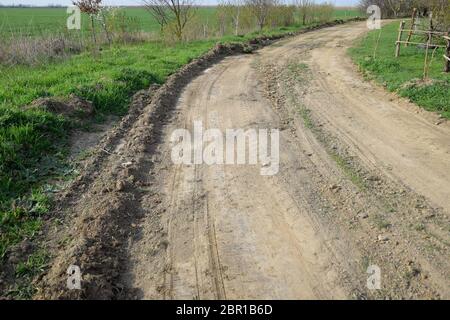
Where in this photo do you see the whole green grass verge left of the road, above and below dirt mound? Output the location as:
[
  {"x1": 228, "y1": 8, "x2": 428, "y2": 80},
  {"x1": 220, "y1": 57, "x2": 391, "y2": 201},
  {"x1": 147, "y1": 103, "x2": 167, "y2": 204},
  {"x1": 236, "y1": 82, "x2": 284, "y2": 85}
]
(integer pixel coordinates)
[{"x1": 0, "y1": 40, "x2": 214, "y2": 257}]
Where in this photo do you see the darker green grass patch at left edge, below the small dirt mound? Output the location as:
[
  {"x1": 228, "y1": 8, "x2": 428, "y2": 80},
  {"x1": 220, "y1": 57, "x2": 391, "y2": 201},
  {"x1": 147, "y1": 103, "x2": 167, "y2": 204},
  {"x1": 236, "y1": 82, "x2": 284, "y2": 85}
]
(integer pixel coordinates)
[{"x1": 0, "y1": 108, "x2": 68, "y2": 259}]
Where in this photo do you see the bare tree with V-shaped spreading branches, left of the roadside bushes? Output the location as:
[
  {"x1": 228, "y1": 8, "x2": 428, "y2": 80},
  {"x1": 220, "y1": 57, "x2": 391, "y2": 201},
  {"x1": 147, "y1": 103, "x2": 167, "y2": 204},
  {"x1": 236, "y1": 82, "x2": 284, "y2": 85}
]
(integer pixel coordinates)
[{"x1": 143, "y1": 0, "x2": 196, "y2": 41}]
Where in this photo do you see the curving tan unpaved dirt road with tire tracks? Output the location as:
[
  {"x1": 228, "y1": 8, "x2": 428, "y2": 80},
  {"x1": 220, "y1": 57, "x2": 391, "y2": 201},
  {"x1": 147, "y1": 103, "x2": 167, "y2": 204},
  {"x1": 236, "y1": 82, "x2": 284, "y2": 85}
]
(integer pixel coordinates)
[{"x1": 37, "y1": 23, "x2": 450, "y2": 299}]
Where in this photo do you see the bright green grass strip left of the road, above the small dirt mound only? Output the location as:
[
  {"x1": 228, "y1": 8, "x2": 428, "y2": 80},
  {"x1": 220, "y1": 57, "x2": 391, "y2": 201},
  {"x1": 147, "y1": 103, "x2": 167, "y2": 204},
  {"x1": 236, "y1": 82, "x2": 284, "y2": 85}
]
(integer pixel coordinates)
[{"x1": 0, "y1": 40, "x2": 214, "y2": 114}]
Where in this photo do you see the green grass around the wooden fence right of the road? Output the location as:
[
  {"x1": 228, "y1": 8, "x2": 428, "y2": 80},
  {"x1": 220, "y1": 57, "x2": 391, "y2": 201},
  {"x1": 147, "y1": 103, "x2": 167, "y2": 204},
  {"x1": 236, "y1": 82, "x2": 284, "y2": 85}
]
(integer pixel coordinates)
[{"x1": 349, "y1": 22, "x2": 450, "y2": 118}]
